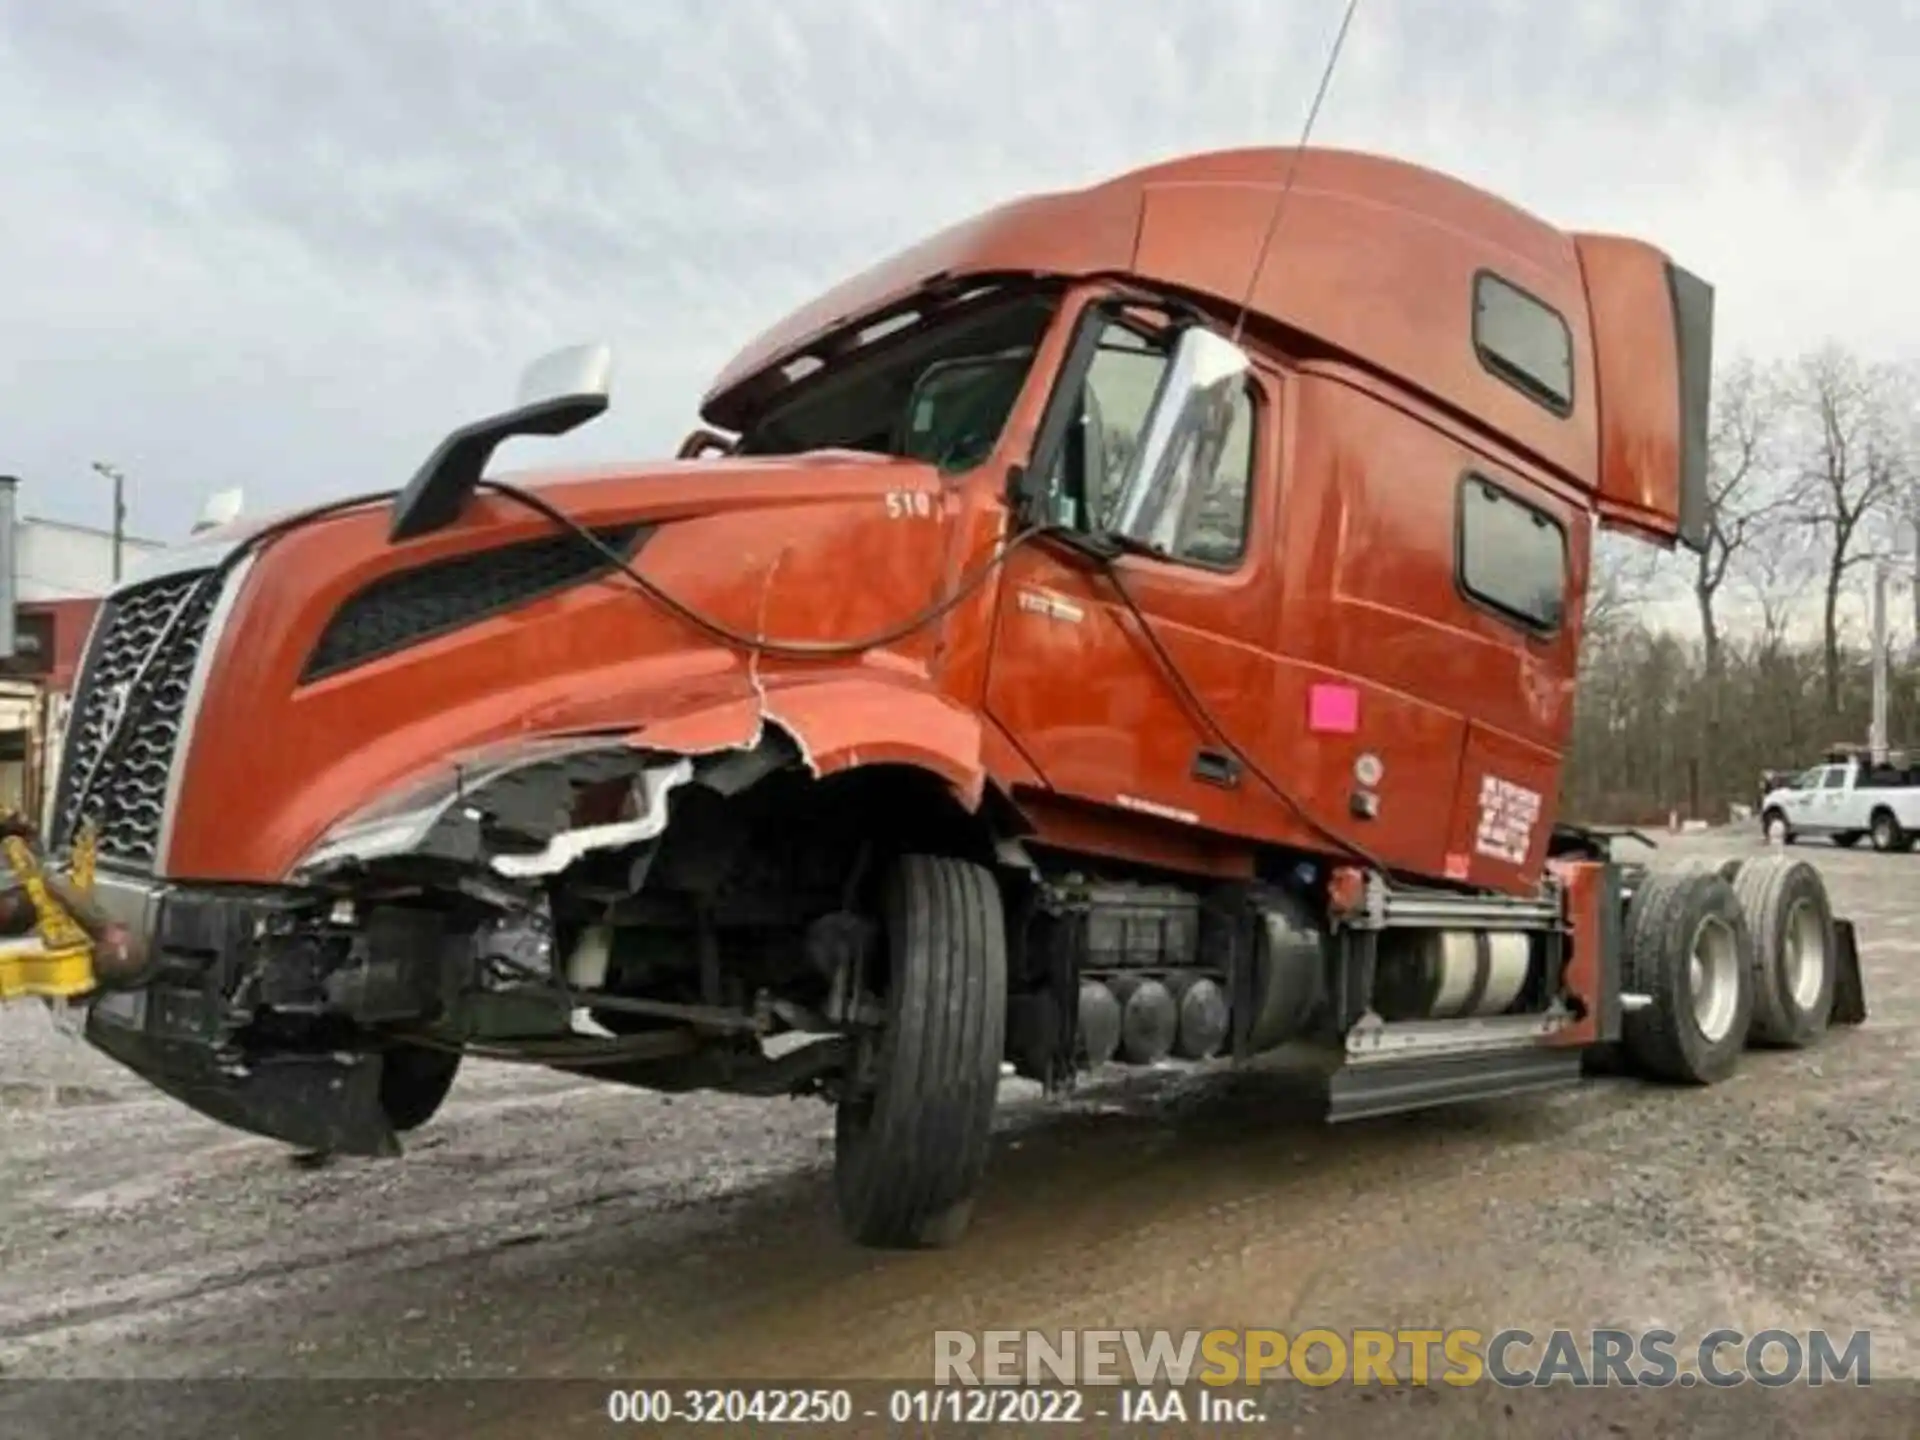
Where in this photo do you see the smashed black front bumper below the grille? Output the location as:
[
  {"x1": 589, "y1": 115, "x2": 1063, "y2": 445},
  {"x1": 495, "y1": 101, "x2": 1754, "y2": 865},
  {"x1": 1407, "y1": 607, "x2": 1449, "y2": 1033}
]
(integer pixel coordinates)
[{"x1": 84, "y1": 872, "x2": 399, "y2": 1156}]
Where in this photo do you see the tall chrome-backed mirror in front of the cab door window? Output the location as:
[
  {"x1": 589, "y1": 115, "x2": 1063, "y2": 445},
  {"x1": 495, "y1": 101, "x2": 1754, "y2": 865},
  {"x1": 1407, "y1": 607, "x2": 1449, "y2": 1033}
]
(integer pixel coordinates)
[{"x1": 1112, "y1": 324, "x2": 1254, "y2": 551}]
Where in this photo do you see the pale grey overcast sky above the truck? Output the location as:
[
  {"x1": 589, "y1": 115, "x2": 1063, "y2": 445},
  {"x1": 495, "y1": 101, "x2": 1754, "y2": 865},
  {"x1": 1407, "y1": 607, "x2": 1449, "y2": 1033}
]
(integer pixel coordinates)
[{"x1": 0, "y1": 0, "x2": 1920, "y2": 538}]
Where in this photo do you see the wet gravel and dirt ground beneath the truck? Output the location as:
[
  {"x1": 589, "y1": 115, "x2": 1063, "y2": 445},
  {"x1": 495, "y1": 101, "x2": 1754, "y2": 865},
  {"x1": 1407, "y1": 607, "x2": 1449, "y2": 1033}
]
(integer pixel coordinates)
[{"x1": 0, "y1": 835, "x2": 1920, "y2": 1436}]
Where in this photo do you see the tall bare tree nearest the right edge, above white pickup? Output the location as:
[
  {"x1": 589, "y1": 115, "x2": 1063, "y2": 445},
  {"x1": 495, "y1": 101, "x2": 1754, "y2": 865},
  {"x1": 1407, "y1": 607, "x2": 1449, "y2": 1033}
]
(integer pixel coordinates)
[{"x1": 1795, "y1": 346, "x2": 1901, "y2": 718}]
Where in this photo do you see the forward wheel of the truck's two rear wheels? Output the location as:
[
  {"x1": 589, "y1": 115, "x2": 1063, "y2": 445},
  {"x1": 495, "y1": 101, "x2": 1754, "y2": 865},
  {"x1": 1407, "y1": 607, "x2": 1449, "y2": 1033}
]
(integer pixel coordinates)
[{"x1": 1620, "y1": 870, "x2": 1753, "y2": 1085}]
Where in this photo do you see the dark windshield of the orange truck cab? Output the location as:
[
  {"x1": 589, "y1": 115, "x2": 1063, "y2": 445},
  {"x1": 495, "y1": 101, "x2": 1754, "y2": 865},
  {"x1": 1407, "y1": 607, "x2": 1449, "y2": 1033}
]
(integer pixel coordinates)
[{"x1": 737, "y1": 296, "x2": 1054, "y2": 474}]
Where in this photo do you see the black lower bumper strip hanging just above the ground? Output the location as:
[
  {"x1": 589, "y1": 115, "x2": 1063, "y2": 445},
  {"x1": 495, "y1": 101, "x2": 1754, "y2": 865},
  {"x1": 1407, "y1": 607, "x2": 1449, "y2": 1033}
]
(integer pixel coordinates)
[{"x1": 86, "y1": 991, "x2": 399, "y2": 1158}]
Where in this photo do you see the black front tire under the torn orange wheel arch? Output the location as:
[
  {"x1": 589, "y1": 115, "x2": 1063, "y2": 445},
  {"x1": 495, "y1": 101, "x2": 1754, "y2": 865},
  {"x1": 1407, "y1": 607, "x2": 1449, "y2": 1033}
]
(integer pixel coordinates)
[{"x1": 833, "y1": 854, "x2": 1006, "y2": 1250}]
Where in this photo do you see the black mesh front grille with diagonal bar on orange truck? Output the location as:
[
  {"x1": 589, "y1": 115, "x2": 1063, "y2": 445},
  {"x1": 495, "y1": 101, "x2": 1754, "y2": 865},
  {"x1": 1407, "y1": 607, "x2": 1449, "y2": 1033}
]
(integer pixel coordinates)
[{"x1": 54, "y1": 570, "x2": 221, "y2": 870}]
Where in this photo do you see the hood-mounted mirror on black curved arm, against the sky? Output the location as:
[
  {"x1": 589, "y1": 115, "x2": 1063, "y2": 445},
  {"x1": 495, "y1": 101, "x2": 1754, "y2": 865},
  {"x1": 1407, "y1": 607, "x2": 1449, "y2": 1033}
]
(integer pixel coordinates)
[{"x1": 386, "y1": 344, "x2": 612, "y2": 541}]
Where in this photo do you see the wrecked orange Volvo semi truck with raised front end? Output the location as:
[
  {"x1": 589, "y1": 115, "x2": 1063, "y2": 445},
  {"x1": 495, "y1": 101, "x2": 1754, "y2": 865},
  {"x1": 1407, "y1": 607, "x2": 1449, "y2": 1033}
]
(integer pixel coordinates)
[{"x1": 33, "y1": 150, "x2": 1864, "y2": 1246}]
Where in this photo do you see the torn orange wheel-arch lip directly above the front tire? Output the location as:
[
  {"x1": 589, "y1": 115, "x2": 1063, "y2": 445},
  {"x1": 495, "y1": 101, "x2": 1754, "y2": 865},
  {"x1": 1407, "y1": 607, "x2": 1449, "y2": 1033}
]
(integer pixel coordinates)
[{"x1": 628, "y1": 676, "x2": 1037, "y2": 810}]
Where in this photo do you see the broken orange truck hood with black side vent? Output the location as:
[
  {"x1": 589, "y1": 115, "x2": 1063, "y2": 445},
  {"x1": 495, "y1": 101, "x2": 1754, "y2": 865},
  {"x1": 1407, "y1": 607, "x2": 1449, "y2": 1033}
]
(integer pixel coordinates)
[{"x1": 149, "y1": 453, "x2": 981, "y2": 883}]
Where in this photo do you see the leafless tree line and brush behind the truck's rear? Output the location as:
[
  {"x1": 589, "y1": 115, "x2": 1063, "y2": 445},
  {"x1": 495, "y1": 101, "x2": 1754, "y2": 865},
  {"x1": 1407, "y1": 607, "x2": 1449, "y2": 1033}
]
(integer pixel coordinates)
[{"x1": 1563, "y1": 348, "x2": 1920, "y2": 824}]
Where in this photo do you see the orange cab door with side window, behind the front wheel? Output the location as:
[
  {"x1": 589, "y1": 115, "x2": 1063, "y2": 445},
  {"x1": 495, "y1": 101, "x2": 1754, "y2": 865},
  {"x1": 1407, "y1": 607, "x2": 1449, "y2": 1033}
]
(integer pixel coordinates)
[{"x1": 987, "y1": 303, "x2": 1279, "y2": 844}]
